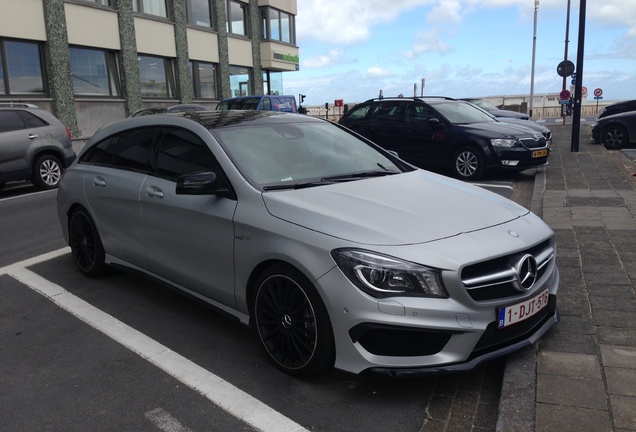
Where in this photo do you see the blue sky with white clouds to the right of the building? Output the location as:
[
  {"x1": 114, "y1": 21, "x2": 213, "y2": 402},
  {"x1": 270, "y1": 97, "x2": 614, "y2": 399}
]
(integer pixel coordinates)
[{"x1": 283, "y1": 0, "x2": 636, "y2": 105}]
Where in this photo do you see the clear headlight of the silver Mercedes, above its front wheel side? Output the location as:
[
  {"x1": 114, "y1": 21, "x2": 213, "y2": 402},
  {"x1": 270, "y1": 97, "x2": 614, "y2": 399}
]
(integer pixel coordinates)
[{"x1": 331, "y1": 249, "x2": 448, "y2": 298}]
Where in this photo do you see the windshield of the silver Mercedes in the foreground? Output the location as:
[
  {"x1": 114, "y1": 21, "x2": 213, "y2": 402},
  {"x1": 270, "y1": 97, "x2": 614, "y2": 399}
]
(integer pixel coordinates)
[{"x1": 212, "y1": 121, "x2": 403, "y2": 189}]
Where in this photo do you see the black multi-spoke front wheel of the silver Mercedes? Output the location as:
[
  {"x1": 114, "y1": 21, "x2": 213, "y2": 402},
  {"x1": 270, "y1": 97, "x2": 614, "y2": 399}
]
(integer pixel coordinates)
[{"x1": 253, "y1": 264, "x2": 335, "y2": 377}]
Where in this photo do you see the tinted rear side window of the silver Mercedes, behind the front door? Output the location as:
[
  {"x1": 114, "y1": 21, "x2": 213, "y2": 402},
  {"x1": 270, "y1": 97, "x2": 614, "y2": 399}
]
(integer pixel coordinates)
[{"x1": 79, "y1": 128, "x2": 157, "y2": 171}]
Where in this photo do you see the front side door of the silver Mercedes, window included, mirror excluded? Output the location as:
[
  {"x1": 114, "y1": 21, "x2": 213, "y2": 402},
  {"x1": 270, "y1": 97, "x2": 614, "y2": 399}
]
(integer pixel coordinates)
[{"x1": 141, "y1": 128, "x2": 236, "y2": 308}]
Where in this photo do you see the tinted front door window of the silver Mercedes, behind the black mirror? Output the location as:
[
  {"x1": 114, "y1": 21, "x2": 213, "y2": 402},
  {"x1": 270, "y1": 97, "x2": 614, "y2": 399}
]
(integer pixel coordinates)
[{"x1": 153, "y1": 129, "x2": 219, "y2": 180}]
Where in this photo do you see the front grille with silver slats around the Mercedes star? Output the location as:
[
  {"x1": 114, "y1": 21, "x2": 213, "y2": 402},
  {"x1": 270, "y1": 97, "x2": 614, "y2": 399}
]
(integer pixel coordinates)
[{"x1": 462, "y1": 238, "x2": 555, "y2": 302}]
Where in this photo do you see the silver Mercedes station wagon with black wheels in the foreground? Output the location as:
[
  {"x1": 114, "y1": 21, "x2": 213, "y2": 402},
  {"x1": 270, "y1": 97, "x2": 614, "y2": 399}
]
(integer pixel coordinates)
[{"x1": 58, "y1": 111, "x2": 559, "y2": 376}]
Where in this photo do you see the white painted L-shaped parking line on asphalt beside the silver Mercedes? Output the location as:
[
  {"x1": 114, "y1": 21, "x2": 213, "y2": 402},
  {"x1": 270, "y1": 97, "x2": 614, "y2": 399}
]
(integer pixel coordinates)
[{"x1": 0, "y1": 248, "x2": 308, "y2": 432}]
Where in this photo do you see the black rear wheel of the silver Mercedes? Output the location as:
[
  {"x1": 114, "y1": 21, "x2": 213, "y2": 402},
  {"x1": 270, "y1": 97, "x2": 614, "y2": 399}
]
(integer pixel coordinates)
[{"x1": 69, "y1": 208, "x2": 106, "y2": 277}]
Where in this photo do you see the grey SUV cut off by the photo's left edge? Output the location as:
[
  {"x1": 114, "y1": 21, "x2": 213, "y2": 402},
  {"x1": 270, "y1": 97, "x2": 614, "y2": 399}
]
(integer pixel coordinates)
[{"x1": 0, "y1": 103, "x2": 75, "y2": 190}]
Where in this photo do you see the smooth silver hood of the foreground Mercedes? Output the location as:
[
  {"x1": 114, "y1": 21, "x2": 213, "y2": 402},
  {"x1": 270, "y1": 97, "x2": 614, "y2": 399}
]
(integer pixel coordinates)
[{"x1": 263, "y1": 170, "x2": 529, "y2": 246}]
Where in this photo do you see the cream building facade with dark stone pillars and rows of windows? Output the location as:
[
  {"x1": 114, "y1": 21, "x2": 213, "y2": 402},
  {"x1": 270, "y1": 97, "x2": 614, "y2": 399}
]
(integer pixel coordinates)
[{"x1": 0, "y1": 0, "x2": 299, "y2": 138}]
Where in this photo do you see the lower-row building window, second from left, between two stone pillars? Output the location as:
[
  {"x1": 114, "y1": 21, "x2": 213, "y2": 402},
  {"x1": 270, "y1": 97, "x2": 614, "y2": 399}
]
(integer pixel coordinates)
[{"x1": 69, "y1": 47, "x2": 119, "y2": 96}]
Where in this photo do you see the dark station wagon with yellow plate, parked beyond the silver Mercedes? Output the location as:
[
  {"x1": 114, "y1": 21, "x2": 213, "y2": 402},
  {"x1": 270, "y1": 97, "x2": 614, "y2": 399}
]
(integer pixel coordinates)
[{"x1": 339, "y1": 97, "x2": 550, "y2": 180}]
